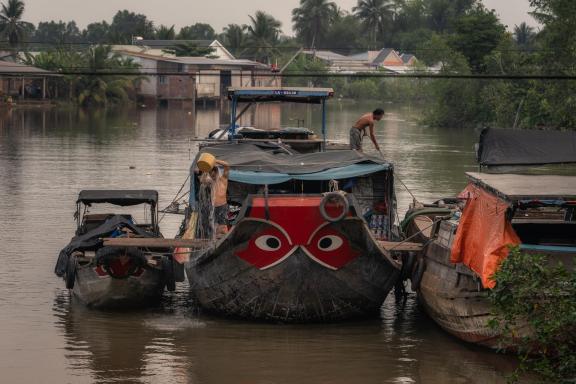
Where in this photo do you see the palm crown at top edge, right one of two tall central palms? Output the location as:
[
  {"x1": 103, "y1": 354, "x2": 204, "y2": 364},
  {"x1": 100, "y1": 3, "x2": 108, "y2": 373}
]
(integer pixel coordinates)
[{"x1": 352, "y1": 0, "x2": 394, "y2": 47}]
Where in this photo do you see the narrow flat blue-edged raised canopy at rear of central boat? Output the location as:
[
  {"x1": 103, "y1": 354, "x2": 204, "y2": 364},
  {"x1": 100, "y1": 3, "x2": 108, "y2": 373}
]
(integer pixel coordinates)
[{"x1": 228, "y1": 87, "x2": 334, "y2": 104}]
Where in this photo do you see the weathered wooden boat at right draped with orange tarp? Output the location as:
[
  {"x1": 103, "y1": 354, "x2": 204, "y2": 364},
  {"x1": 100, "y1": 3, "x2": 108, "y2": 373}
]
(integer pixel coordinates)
[{"x1": 402, "y1": 131, "x2": 576, "y2": 348}]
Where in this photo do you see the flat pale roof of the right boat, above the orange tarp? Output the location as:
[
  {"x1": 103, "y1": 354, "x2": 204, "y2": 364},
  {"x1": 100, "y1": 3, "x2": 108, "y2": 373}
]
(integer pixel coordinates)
[{"x1": 466, "y1": 172, "x2": 576, "y2": 202}]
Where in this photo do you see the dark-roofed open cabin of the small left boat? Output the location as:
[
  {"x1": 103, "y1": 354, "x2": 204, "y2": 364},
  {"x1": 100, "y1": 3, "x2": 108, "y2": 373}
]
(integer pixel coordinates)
[{"x1": 74, "y1": 190, "x2": 160, "y2": 236}]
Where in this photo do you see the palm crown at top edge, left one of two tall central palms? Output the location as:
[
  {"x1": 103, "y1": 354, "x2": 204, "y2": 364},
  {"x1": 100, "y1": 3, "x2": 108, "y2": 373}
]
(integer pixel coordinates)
[{"x1": 292, "y1": 0, "x2": 338, "y2": 48}]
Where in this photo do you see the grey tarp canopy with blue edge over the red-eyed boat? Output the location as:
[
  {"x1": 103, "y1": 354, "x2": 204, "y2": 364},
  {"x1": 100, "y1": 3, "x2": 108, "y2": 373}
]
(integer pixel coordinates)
[{"x1": 192, "y1": 143, "x2": 393, "y2": 185}]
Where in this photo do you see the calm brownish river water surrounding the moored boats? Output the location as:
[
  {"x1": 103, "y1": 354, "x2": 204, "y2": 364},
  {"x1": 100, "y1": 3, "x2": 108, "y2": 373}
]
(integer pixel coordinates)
[{"x1": 0, "y1": 101, "x2": 515, "y2": 384}]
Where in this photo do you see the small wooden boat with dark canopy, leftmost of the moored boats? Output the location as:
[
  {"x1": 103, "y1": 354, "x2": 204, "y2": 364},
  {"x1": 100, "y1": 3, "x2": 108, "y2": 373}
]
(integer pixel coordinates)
[{"x1": 55, "y1": 190, "x2": 175, "y2": 308}]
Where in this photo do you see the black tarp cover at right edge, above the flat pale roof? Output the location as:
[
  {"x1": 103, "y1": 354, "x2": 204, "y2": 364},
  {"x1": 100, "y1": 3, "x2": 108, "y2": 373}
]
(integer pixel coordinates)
[{"x1": 478, "y1": 128, "x2": 576, "y2": 166}]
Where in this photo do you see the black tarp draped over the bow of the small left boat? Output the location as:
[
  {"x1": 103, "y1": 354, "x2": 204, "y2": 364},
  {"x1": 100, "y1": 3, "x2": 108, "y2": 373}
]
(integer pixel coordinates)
[{"x1": 54, "y1": 215, "x2": 155, "y2": 277}]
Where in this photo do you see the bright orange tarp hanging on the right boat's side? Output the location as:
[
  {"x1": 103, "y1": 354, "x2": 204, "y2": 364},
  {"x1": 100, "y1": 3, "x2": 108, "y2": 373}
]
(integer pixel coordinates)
[{"x1": 450, "y1": 184, "x2": 520, "y2": 288}]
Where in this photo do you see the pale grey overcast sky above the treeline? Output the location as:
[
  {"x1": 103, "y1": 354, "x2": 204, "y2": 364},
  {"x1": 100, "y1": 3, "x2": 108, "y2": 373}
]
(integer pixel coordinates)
[{"x1": 24, "y1": 0, "x2": 536, "y2": 34}]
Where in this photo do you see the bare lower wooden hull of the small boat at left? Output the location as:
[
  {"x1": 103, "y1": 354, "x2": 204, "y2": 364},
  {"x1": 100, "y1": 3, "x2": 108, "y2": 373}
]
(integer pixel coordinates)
[{"x1": 71, "y1": 265, "x2": 165, "y2": 308}]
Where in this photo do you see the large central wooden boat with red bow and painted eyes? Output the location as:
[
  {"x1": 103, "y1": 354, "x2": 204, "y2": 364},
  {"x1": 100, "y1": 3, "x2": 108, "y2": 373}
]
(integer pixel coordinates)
[{"x1": 176, "y1": 88, "x2": 401, "y2": 323}]
